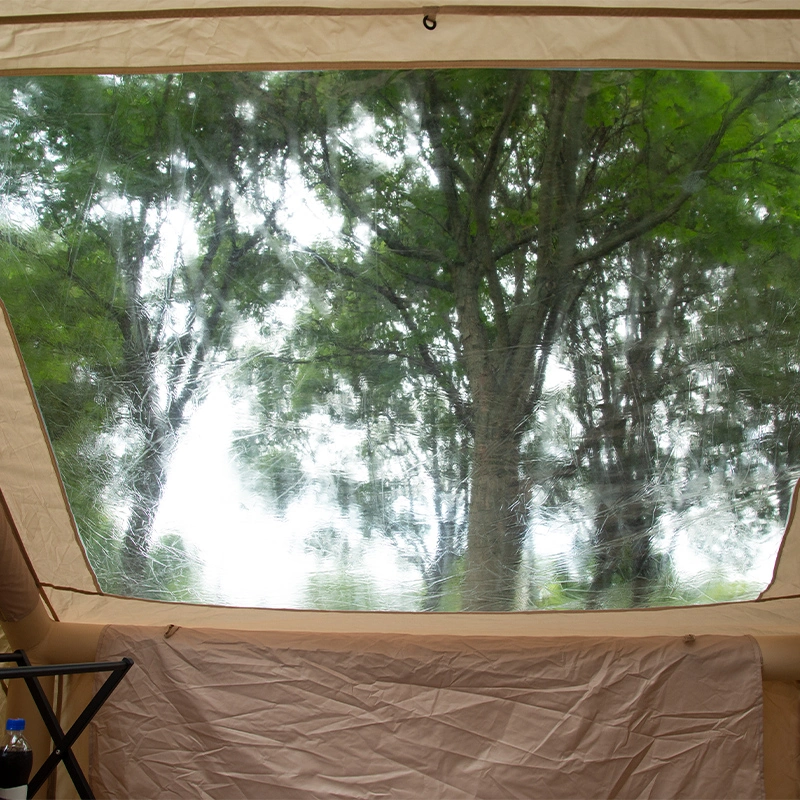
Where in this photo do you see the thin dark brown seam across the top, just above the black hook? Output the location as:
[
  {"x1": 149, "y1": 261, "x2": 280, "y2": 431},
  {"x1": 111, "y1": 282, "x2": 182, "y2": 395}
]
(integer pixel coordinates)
[{"x1": 0, "y1": 5, "x2": 800, "y2": 25}]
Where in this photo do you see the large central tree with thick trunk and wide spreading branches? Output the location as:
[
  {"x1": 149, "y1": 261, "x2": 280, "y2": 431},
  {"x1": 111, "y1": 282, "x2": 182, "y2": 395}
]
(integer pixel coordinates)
[{"x1": 266, "y1": 71, "x2": 796, "y2": 610}]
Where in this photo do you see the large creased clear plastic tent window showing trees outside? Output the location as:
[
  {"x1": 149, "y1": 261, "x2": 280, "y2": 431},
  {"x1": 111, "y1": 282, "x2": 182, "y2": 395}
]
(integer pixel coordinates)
[{"x1": 0, "y1": 70, "x2": 800, "y2": 611}]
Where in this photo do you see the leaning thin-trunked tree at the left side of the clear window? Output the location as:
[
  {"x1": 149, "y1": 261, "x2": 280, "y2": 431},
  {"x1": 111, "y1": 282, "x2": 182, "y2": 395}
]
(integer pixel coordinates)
[{"x1": 3, "y1": 76, "x2": 290, "y2": 595}]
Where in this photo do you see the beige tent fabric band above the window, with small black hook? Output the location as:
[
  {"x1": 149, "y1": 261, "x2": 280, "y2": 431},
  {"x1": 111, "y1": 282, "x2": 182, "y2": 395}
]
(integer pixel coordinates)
[{"x1": 0, "y1": 0, "x2": 800, "y2": 74}]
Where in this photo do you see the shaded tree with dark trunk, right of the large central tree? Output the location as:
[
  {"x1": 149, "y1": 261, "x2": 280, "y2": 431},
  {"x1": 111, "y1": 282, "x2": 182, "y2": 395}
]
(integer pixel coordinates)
[{"x1": 548, "y1": 83, "x2": 797, "y2": 605}]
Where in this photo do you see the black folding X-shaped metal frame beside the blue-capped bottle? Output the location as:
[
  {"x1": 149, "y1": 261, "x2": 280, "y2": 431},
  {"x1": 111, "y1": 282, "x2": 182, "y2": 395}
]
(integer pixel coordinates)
[{"x1": 0, "y1": 650, "x2": 133, "y2": 800}]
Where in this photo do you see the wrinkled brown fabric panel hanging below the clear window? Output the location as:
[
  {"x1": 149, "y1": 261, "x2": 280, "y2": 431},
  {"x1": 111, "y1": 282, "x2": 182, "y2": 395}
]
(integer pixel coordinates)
[{"x1": 91, "y1": 626, "x2": 763, "y2": 800}]
